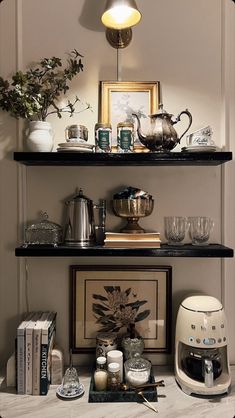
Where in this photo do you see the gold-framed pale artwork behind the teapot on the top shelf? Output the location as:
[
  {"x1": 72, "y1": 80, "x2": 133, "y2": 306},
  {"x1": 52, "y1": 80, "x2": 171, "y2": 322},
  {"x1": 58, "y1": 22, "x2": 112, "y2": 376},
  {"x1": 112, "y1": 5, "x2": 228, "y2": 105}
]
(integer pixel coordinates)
[{"x1": 99, "y1": 81, "x2": 160, "y2": 140}]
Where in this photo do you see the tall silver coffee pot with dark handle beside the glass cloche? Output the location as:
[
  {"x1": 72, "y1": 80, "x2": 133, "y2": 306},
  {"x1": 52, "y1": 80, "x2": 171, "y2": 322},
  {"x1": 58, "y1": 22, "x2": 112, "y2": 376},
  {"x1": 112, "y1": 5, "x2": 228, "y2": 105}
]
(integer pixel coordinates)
[{"x1": 64, "y1": 189, "x2": 106, "y2": 247}]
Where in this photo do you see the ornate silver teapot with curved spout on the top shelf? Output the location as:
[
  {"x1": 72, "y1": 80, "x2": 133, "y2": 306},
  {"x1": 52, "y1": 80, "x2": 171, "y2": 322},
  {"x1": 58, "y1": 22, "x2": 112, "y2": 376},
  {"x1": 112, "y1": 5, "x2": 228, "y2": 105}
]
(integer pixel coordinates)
[{"x1": 132, "y1": 104, "x2": 192, "y2": 152}]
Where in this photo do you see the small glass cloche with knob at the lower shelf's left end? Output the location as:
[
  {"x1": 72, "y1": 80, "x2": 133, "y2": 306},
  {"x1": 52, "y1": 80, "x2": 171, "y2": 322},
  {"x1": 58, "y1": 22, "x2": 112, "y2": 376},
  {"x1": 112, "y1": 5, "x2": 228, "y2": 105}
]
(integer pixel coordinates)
[{"x1": 24, "y1": 212, "x2": 62, "y2": 247}]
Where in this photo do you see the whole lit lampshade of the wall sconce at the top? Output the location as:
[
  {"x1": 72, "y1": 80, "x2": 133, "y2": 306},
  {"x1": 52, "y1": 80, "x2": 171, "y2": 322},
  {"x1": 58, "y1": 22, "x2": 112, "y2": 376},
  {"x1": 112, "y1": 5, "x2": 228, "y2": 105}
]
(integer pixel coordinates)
[{"x1": 101, "y1": 0, "x2": 141, "y2": 30}]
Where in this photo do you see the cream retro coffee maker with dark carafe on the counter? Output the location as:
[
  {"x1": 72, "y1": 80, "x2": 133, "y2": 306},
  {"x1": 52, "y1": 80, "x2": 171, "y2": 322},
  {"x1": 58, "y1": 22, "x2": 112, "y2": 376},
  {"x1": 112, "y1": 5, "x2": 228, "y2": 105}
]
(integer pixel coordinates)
[{"x1": 175, "y1": 295, "x2": 231, "y2": 396}]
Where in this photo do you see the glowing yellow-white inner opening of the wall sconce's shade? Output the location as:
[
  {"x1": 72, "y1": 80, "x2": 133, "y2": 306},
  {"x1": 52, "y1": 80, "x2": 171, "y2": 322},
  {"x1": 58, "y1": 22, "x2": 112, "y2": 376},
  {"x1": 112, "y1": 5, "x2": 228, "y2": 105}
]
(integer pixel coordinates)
[{"x1": 101, "y1": 5, "x2": 141, "y2": 29}]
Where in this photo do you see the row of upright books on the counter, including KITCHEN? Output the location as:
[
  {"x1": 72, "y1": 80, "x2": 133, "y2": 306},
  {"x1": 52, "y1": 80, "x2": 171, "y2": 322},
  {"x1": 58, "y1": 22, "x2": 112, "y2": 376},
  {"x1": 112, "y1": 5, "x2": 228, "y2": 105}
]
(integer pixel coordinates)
[{"x1": 16, "y1": 311, "x2": 56, "y2": 395}]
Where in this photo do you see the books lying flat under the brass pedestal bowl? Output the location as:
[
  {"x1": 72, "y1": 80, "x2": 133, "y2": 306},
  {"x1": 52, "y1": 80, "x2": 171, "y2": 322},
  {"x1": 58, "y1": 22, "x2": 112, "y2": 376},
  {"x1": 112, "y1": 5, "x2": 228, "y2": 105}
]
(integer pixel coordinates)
[{"x1": 104, "y1": 232, "x2": 161, "y2": 248}]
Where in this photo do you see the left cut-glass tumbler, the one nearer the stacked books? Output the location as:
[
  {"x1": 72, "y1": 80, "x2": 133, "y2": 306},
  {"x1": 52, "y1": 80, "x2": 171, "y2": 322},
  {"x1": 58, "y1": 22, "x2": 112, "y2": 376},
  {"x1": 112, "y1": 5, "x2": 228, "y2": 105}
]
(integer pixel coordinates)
[{"x1": 164, "y1": 216, "x2": 188, "y2": 245}]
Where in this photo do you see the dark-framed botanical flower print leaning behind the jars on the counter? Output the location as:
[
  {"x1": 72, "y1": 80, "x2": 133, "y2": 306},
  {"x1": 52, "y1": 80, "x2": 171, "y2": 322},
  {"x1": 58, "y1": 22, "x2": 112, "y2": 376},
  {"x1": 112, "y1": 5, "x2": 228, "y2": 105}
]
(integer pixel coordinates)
[{"x1": 70, "y1": 265, "x2": 172, "y2": 353}]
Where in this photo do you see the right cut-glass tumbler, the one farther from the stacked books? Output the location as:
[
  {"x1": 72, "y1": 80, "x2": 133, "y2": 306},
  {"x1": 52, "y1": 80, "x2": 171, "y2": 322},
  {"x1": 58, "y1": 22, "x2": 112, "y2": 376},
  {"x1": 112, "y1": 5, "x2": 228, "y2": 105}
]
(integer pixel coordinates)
[{"x1": 189, "y1": 216, "x2": 214, "y2": 245}]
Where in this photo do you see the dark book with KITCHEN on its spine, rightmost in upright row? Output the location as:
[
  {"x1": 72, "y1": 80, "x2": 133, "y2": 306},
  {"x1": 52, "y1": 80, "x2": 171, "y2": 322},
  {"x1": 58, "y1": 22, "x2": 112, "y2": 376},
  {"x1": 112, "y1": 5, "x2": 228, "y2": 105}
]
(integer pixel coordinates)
[{"x1": 40, "y1": 319, "x2": 55, "y2": 395}]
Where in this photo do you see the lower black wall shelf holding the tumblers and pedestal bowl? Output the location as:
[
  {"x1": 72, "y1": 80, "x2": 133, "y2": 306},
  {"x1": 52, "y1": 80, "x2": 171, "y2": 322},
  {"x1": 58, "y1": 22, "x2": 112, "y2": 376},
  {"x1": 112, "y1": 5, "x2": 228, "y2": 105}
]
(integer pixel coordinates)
[{"x1": 15, "y1": 244, "x2": 233, "y2": 258}]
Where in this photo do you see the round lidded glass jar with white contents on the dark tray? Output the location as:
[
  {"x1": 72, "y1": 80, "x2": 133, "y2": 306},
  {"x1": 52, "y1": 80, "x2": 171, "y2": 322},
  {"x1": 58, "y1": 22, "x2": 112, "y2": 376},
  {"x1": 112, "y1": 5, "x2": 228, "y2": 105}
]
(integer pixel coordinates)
[{"x1": 124, "y1": 357, "x2": 151, "y2": 386}]
